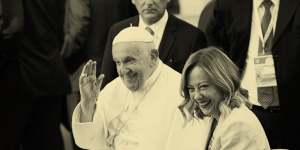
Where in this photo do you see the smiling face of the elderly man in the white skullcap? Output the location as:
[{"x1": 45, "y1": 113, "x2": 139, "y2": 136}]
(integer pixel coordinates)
[{"x1": 112, "y1": 42, "x2": 153, "y2": 91}]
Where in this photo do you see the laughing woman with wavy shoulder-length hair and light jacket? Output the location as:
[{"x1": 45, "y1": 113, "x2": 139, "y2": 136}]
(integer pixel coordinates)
[{"x1": 179, "y1": 47, "x2": 270, "y2": 150}]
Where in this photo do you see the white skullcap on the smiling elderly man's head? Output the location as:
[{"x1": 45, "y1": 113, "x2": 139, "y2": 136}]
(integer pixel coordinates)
[{"x1": 112, "y1": 27, "x2": 154, "y2": 45}]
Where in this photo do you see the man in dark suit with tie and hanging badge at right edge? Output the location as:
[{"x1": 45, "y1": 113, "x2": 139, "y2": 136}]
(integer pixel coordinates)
[{"x1": 208, "y1": 0, "x2": 300, "y2": 149}]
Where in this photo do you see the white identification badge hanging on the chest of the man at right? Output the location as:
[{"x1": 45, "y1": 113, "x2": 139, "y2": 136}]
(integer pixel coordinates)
[{"x1": 254, "y1": 55, "x2": 277, "y2": 87}]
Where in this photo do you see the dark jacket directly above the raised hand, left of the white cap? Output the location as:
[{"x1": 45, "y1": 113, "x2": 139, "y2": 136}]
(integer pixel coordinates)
[{"x1": 86, "y1": 0, "x2": 138, "y2": 66}]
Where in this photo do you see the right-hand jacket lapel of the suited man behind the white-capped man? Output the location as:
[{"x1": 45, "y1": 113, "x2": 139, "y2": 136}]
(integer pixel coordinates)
[{"x1": 158, "y1": 15, "x2": 177, "y2": 61}]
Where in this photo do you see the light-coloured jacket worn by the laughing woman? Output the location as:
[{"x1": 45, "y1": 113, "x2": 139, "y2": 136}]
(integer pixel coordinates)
[{"x1": 208, "y1": 105, "x2": 271, "y2": 150}]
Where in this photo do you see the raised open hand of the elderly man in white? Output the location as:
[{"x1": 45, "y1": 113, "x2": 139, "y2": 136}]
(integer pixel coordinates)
[{"x1": 79, "y1": 60, "x2": 104, "y2": 120}]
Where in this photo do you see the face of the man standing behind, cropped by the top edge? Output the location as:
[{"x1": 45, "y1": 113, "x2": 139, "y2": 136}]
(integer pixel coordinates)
[{"x1": 132, "y1": 0, "x2": 169, "y2": 24}]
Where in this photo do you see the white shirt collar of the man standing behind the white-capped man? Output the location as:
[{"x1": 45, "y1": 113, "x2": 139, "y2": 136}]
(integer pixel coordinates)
[{"x1": 139, "y1": 10, "x2": 169, "y2": 33}]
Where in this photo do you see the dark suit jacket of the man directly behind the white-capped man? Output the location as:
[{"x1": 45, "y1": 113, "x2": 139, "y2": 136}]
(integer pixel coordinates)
[{"x1": 101, "y1": 15, "x2": 206, "y2": 87}]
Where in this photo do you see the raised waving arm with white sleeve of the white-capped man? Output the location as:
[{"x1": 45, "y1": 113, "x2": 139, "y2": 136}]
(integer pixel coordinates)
[{"x1": 72, "y1": 60, "x2": 107, "y2": 149}]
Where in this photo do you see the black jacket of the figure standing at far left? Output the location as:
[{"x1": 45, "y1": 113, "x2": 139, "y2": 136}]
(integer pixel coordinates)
[{"x1": 18, "y1": 0, "x2": 70, "y2": 96}]
